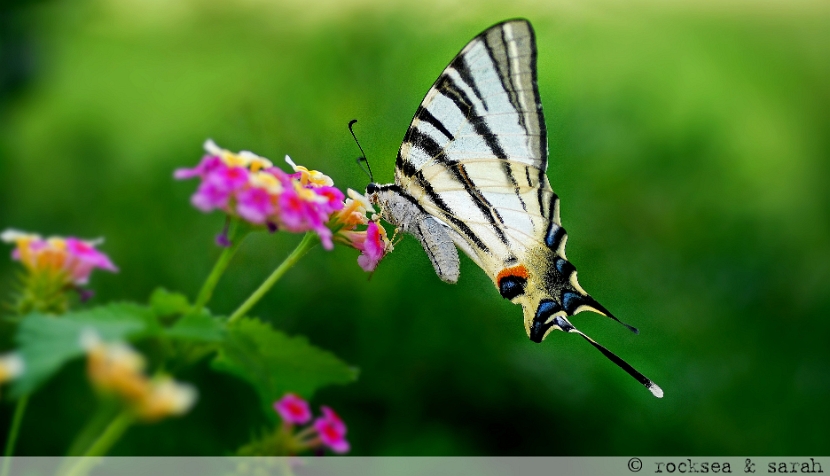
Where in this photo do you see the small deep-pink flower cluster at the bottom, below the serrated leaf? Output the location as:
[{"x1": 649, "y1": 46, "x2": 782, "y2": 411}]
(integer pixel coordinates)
[{"x1": 274, "y1": 393, "x2": 349, "y2": 454}]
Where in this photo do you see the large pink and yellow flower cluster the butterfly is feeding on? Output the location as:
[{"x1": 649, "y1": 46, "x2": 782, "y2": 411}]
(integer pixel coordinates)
[{"x1": 174, "y1": 140, "x2": 392, "y2": 271}]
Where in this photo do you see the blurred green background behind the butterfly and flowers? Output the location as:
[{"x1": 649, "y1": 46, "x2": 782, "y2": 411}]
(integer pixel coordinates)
[{"x1": 0, "y1": 0, "x2": 830, "y2": 455}]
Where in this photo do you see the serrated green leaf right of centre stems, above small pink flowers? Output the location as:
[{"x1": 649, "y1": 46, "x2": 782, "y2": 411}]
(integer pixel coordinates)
[{"x1": 212, "y1": 318, "x2": 357, "y2": 407}]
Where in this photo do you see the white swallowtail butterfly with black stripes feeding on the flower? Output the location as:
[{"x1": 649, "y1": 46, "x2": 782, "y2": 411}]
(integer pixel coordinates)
[{"x1": 366, "y1": 19, "x2": 663, "y2": 397}]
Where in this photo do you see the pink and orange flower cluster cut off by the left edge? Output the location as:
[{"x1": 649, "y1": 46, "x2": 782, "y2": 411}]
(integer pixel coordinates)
[{"x1": 0, "y1": 229, "x2": 118, "y2": 314}]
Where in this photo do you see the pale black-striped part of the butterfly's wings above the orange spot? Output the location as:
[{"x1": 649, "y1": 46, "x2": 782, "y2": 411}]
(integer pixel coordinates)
[{"x1": 395, "y1": 20, "x2": 558, "y2": 281}]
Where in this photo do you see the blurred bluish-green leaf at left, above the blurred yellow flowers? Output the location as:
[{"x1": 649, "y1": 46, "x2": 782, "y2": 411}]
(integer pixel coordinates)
[{"x1": 11, "y1": 303, "x2": 160, "y2": 397}]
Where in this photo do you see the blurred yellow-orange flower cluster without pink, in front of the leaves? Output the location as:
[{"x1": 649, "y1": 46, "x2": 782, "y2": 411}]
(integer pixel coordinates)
[{"x1": 81, "y1": 330, "x2": 196, "y2": 421}]
